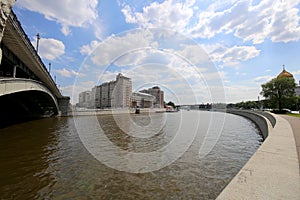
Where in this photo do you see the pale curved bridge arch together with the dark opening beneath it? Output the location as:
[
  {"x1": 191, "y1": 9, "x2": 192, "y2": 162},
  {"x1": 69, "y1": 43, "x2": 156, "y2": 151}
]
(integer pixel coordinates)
[{"x1": 0, "y1": 78, "x2": 59, "y2": 127}]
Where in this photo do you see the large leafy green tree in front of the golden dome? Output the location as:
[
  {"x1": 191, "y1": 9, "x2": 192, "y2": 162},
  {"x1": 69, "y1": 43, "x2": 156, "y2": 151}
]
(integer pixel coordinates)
[{"x1": 260, "y1": 77, "x2": 296, "y2": 110}]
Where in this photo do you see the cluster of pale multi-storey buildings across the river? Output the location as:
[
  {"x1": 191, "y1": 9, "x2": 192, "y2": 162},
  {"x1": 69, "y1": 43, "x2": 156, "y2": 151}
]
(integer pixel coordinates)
[{"x1": 76, "y1": 73, "x2": 165, "y2": 109}]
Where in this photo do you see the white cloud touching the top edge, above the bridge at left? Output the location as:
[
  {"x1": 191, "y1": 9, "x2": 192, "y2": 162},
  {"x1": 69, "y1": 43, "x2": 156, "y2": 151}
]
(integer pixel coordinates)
[{"x1": 16, "y1": 0, "x2": 98, "y2": 35}]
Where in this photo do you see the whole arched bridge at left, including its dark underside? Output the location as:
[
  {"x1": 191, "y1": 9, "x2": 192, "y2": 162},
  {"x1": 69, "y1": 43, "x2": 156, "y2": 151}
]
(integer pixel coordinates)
[{"x1": 0, "y1": 3, "x2": 70, "y2": 127}]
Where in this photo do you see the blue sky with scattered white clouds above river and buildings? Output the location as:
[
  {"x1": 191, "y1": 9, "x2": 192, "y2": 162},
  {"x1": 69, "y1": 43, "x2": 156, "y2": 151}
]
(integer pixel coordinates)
[{"x1": 13, "y1": 0, "x2": 300, "y2": 105}]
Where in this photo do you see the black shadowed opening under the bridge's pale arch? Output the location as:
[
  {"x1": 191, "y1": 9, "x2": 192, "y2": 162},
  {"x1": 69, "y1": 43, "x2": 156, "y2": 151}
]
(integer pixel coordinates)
[{"x1": 0, "y1": 91, "x2": 57, "y2": 128}]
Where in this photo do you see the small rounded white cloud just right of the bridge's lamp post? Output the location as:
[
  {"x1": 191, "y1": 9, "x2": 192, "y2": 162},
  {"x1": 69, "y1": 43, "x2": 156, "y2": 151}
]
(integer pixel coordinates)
[{"x1": 32, "y1": 37, "x2": 65, "y2": 60}]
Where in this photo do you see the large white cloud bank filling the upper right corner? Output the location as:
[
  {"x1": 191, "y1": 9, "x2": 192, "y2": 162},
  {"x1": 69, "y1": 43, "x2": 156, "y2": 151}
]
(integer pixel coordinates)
[{"x1": 188, "y1": 0, "x2": 300, "y2": 44}]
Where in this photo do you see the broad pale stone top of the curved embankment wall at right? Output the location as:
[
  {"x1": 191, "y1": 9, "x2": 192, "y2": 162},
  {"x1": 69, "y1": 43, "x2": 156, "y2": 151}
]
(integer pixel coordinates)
[{"x1": 217, "y1": 112, "x2": 300, "y2": 200}]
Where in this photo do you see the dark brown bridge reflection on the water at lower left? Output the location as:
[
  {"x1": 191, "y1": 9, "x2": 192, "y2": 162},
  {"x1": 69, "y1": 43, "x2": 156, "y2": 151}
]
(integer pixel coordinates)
[{"x1": 0, "y1": 118, "x2": 61, "y2": 199}]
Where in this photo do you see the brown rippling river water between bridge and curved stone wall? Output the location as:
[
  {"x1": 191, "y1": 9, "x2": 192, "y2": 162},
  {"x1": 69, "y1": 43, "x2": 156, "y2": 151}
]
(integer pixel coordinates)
[{"x1": 0, "y1": 111, "x2": 262, "y2": 199}]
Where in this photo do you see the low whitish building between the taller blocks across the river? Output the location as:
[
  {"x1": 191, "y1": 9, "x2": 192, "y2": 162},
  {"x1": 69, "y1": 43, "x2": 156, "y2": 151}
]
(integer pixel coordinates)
[{"x1": 132, "y1": 92, "x2": 156, "y2": 108}]
